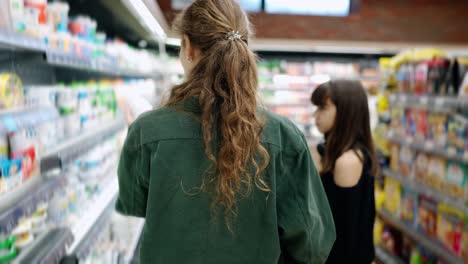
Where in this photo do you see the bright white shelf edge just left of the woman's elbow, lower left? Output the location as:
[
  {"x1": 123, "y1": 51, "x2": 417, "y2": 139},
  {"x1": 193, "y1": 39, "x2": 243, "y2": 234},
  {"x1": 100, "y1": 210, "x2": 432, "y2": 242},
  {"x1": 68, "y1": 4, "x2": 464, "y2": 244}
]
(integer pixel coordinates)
[{"x1": 67, "y1": 177, "x2": 119, "y2": 254}]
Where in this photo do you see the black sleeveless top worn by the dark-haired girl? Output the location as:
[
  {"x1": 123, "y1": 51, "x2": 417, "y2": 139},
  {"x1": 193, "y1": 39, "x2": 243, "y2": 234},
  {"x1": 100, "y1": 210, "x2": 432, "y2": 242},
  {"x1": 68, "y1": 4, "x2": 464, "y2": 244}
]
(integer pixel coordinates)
[{"x1": 317, "y1": 144, "x2": 376, "y2": 264}]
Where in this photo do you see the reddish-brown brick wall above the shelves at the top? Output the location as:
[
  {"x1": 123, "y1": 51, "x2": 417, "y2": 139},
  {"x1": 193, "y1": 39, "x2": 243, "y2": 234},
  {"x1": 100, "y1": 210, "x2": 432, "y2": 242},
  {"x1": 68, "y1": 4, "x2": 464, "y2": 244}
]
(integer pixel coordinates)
[{"x1": 157, "y1": 0, "x2": 468, "y2": 44}]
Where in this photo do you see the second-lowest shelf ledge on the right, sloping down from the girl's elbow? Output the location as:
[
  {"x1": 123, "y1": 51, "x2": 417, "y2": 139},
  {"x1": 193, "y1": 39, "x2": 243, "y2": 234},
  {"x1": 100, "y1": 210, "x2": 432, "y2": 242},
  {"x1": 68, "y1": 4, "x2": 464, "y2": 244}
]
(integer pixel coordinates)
[{"x1": 383, "y1": 169, "x2": 468, "y2": 214}]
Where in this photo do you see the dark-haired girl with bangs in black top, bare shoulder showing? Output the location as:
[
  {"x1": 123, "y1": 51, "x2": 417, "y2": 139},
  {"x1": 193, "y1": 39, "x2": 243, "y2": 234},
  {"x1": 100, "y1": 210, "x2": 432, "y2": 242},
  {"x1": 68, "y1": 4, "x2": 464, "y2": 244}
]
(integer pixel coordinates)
[{"x1": 311, "y1": 80, "x2": 378, "y2": 264}]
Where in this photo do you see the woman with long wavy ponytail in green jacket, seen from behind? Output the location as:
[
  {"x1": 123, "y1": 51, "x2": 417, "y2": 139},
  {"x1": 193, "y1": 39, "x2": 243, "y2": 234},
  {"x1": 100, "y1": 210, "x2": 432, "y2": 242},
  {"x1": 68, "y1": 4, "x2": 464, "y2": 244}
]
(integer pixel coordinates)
[{"x1": 116, "y1": 0, "x2": 335, "y2": 264}]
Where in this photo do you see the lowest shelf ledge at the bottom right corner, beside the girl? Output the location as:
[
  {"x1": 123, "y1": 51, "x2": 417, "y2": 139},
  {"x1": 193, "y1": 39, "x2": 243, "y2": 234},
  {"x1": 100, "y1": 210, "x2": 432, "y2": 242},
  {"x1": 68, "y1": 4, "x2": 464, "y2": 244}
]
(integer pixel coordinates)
[{"x1": 378, "y1": 210, "x2": 463, "y2": 264}]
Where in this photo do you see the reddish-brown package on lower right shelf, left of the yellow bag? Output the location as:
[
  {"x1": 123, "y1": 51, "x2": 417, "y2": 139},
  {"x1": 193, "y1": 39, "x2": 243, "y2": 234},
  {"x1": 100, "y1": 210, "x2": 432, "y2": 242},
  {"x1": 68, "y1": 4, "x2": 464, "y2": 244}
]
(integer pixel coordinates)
[{"x1": 417, "y1": 195, "x2": 437, "y2": 237}]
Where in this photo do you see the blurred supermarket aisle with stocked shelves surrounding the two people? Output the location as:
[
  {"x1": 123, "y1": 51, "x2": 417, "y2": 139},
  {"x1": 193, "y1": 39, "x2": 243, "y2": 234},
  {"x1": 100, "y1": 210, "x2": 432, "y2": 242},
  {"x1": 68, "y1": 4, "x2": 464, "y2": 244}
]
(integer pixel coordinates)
[{"x1": 0, "y1": 0, "x2": 468, "y2": 264}]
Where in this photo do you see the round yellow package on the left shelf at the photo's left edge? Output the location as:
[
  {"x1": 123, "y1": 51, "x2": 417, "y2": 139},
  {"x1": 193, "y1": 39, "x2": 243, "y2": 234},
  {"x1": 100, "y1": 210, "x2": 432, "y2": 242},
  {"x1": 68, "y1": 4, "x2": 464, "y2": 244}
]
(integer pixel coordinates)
[{"x1": 0, "y1": 73, "x2": 24, "y2": 109}]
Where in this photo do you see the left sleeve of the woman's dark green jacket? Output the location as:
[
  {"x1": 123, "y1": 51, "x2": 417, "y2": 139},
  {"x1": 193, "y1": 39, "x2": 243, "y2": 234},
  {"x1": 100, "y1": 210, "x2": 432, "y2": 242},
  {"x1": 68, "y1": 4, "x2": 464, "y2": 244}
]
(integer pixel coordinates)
[{"x1": 116, "y1": 121, "x2": 149, "y2": 217}]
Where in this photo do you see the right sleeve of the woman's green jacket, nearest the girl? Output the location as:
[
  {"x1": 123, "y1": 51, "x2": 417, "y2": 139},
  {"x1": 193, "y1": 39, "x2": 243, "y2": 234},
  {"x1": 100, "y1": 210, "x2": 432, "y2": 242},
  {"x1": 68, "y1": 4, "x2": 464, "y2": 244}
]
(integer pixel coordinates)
[{"x1": 277, "y1": 136, "x2": 336, "y2": 264}]
